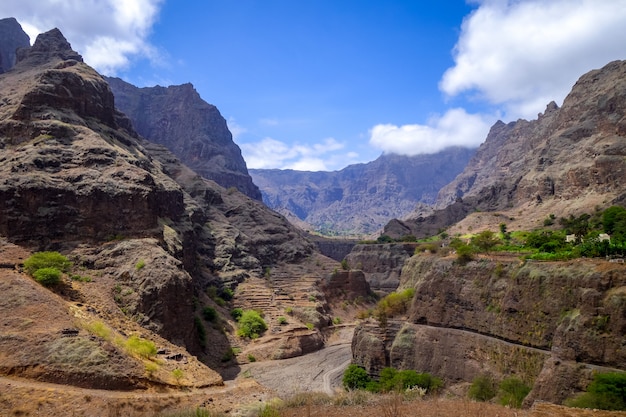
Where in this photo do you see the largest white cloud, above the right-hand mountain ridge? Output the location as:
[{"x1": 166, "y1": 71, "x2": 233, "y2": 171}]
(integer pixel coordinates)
[{"x1": 440, "y1": 0, "x2": 626, "y2": 119}]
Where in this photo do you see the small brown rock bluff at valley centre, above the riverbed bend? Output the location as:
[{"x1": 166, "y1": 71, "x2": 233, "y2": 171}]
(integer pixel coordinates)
[{"x1": 346, "y1": 243, "x2": 417, "y2": 293}]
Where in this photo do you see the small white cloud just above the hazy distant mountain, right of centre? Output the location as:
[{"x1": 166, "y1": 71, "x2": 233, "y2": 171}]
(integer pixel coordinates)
[{"x1": 370, "y1": 109, "x2": 494, "y2": 155}]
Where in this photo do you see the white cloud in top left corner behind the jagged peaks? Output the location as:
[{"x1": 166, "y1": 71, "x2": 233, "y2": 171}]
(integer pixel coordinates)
[{"x1": 0, "y1": 0, "x2": 163, "y2": 75}]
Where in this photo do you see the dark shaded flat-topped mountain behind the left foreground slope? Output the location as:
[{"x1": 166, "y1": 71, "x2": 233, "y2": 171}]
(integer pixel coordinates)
[{"x1": 106, "y1": 78, "x2": 261, "y2": 200}]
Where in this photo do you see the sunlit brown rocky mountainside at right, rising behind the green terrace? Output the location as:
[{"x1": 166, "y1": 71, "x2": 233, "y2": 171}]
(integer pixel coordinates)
[{"x1": 385, "y1": 61, "x2": 626, "y2": 236}]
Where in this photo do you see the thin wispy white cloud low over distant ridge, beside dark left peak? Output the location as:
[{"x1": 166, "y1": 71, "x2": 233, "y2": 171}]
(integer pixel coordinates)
[{"x1": 239, "y1": 138, "x2": 358, "y2": 171}]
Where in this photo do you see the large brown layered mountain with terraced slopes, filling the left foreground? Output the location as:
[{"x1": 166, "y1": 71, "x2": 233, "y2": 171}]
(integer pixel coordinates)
[{"x1": 0, "y1": 24, "x2": 358, "y2": 389}]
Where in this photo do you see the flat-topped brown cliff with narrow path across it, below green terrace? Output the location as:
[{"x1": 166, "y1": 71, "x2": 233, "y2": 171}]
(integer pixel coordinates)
[{"x1": 353, "y1": 254, "x2": 626, "y2": 402}]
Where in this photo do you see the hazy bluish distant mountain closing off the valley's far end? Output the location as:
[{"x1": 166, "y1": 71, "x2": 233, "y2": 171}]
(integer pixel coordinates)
[{"x1": 250, "y1": 147, "x2": 474, "y2": 235}]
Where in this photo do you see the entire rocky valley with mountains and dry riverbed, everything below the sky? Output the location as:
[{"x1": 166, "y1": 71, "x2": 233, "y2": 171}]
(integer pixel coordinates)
[{"x1": 0, "y1": 14, "x2": 626, "y2": 417}]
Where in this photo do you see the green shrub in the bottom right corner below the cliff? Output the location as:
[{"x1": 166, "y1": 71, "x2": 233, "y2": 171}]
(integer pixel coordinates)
[{"x1": 566, "y1": 372, "x2": 626, "y2": 410}]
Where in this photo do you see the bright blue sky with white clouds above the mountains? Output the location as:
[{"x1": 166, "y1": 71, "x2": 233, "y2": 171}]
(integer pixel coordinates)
[{"x1": 0, "y1": 0, "x2": 626, "y2": 170}]
